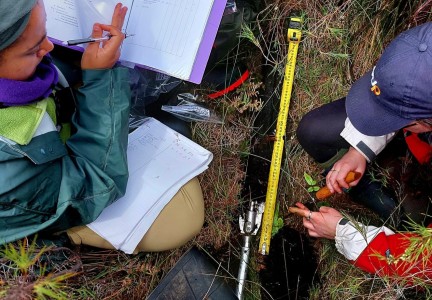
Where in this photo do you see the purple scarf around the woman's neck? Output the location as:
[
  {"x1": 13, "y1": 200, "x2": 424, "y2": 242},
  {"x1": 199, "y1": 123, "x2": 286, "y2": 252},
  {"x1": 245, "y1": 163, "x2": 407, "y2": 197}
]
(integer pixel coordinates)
[{"x1": 0, "y1": 58, "x2": 58, "y2": 106}]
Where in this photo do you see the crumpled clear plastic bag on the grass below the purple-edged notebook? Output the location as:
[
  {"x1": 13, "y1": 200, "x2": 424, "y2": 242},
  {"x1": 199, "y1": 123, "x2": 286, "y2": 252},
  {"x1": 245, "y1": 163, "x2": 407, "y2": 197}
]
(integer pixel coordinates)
[{"x1": 161, "y1": 93, "x2": 223, "y2": 124}]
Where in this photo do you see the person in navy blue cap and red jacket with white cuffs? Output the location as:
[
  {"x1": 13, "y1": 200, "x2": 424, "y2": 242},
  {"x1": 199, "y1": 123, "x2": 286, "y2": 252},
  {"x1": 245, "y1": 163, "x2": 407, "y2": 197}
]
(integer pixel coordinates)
[{"x1": 290, "y1": 23, "x2": 432, "y2": 284}]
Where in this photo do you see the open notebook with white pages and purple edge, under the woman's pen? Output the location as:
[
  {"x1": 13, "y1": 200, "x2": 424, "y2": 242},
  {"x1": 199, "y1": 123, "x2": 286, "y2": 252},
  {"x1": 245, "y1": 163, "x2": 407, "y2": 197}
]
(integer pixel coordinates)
[{"x1": 44, "y1": 0, "x2": 226, "y2": 83}]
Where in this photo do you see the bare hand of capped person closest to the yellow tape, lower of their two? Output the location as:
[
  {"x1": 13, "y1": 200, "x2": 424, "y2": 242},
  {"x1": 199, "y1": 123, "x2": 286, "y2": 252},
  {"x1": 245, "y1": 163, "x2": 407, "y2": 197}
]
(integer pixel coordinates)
[{"x1": 289, "y1": 202, "x2": 342, "y2": 239}]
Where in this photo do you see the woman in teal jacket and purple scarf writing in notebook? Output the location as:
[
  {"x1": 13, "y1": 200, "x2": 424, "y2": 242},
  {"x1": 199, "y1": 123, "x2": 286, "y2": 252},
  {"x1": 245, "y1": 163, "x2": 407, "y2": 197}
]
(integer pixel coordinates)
[{"x1": 0, "y1": 0, "x2": 204, "y2": 251}]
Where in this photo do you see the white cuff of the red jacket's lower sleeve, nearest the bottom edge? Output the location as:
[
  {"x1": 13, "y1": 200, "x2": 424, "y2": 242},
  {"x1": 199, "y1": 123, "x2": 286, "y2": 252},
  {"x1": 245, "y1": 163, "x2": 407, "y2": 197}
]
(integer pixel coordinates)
[{"x1": 335, "y1": 218, "x2": 394, "y2": 260}]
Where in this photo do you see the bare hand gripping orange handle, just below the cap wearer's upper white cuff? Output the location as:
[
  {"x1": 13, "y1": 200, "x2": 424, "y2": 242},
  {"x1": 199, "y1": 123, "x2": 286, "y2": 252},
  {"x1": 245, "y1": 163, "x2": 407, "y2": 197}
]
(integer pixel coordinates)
[{"x1": 326, "y1": 147, "x2": 366, "y2": 193}]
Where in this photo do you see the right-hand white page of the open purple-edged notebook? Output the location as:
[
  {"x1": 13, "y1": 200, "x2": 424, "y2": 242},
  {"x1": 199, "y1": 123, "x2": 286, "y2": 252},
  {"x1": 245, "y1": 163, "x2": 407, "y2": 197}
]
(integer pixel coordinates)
[{"x1": 121, "y1": 0, "x2": 213, "y2": 79}]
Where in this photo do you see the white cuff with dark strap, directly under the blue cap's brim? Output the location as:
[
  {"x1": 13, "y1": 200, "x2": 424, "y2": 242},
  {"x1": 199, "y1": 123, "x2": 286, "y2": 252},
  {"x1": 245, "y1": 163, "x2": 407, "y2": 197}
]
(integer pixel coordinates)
[{"x1": 340, "y1": 118, "x2": 395, "y2": 162}]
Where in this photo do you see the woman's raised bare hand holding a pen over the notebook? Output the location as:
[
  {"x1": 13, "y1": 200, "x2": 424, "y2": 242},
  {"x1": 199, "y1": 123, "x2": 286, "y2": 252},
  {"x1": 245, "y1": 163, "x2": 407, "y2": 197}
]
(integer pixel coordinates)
[{"x1": 81, "y1": 3, "x2": 127, "y2": 70}]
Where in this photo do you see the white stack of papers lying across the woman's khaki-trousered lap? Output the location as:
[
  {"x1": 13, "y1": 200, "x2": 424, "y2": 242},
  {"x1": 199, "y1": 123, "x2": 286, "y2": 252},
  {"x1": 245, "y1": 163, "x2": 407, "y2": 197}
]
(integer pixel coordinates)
[{"x1": 88, "y1": 118, "x2": 213, "y2": 254}]
